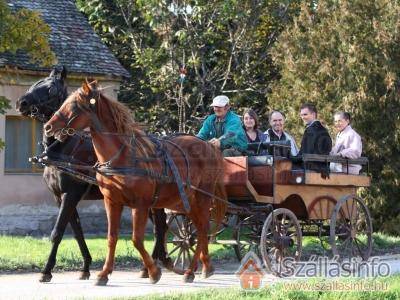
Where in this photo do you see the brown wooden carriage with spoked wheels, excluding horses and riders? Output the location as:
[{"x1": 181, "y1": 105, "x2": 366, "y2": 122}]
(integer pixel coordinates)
[{"x1": 164, "y1": 142, "x2": 372, "y2": 275}]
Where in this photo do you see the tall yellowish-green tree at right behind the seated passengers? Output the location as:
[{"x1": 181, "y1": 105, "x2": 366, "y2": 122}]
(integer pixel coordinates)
[{"x1": 269, "y1": 0, "x2": 400, "y2": 234}]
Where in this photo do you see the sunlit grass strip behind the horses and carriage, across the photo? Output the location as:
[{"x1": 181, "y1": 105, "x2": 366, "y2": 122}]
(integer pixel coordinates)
[{"x1": 0, "y1": 230, "x2": 400, "y2": 272}]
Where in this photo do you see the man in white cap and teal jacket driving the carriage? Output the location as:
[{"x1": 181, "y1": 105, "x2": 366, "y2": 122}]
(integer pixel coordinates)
[{"x1": 197, "y1": 95, "x2": 247, "y2": 156}]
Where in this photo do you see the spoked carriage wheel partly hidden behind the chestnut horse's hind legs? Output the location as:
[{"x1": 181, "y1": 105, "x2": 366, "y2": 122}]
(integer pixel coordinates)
[{"x1": 167, "y1": 214, "x2": 197, "y2": 274}]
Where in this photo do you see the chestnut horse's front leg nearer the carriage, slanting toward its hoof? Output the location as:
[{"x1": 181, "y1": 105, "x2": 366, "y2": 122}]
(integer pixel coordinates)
[{"x1": 132, "y1": 209, "x2": 161, "y2": 283}]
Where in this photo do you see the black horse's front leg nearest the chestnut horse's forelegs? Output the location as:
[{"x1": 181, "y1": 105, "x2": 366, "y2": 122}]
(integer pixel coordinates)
[{"x1": 69, "y1": 208, "x2": 92, "y2": 280}]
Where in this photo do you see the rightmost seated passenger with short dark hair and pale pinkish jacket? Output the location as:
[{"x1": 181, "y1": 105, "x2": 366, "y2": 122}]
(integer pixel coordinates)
[{"x1": 331, "y1": 112, "x2": 362, "y2": 174}]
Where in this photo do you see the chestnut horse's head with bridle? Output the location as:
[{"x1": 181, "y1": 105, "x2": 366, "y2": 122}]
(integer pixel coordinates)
[{"x1": 44, "y1": 80, "x2": 100, "y2": 141}]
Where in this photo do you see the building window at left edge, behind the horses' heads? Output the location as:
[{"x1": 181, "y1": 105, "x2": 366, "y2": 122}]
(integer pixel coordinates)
[{"x1": 5, "y1": 116, "x2": 43, "y2": 174}]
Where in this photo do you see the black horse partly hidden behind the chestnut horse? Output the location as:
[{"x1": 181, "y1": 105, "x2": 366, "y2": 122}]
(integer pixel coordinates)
[{"x1": 16, "y1": 67, "x2": 172, "y2": 282}]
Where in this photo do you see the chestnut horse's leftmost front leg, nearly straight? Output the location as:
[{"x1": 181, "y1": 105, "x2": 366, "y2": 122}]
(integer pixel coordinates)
[{"x1": 96, "y1": 198, "x2": 123, "y2": 285}]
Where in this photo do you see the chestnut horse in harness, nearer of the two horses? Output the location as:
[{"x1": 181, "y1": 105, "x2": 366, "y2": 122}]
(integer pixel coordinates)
[{"x1": 44, "y1": 82, "x2": 226, "y2": 285}]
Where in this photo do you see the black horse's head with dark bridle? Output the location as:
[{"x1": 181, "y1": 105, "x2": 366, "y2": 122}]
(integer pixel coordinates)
[{"x1": 16, "y1": 67, "x2": 67, "y2": 122}]
